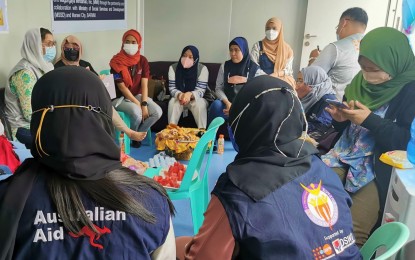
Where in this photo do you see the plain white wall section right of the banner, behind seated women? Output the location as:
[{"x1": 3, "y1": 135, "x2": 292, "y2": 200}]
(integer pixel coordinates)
[{"x1": 144, "y1": 0, "x2": 307, "y2": 73}]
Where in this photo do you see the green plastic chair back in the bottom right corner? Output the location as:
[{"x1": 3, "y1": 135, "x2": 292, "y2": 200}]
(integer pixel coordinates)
[{"x1": 360, "y1": 222, "x2": 409, "y2": 260}]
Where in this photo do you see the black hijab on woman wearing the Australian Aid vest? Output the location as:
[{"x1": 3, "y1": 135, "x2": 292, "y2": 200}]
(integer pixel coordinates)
[{"x1": 0, "y1": 66, "x2": 121, "y2": 259}]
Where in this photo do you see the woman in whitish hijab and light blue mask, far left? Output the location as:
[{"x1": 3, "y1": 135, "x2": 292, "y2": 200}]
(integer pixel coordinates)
[{"x1": 5, "y1": 28, "x2": 56, "y2": 148}]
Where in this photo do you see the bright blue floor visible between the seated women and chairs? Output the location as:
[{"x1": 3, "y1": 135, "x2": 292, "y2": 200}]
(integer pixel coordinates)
[{"x1": 130, "y1": 135, "x2": 236, "y2": 236}]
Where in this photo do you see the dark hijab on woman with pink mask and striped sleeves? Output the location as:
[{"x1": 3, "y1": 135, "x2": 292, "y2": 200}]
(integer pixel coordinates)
[{"x1": 175, "y1": 45, "x2": 199, "y2": 93}]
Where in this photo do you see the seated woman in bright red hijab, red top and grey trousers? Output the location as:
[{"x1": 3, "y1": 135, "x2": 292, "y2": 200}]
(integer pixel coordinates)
[{"x1": 110, "y1": 29, "x2": 163, "y2": 147}]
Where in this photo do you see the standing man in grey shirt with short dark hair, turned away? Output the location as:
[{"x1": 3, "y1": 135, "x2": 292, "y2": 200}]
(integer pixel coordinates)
[{"x1": 311, "y1": 7, "x2": 368, "y2": 100}]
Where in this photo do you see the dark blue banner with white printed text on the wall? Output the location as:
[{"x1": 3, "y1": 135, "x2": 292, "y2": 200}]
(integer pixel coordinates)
[{"x1": 51, "y1": 0, "x2": 127, "y2": 33}]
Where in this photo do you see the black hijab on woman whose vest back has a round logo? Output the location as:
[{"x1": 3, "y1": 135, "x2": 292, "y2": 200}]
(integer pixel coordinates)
[{"x1": 226, "y1": 75, "x2": 317, "y2": 201}]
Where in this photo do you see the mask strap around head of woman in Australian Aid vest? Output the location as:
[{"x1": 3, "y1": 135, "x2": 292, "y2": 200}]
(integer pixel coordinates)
[{"x1": 32, "y1": 105, "x2": 111, "y2": 157}]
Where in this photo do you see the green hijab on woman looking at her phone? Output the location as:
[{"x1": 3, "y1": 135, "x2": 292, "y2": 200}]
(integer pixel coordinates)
[{"x1": 345, "y1": 27, "x2": 415, "y2": 111}]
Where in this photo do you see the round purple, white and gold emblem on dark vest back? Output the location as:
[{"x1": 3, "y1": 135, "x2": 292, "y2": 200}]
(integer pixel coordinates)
[{"x1": 301, "y1": 180, "x2": 339, "y2": 230}]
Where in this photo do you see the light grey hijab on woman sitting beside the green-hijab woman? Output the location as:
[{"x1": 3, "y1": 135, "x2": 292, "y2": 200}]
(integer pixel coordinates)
[{"x1": 301, "y1": 66, "x2": 335, "y2": 113}]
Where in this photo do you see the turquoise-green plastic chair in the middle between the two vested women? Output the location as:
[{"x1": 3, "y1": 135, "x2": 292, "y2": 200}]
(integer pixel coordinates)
[{"x1": 144, "y1": 117, "x2": 225, "y2": 234}]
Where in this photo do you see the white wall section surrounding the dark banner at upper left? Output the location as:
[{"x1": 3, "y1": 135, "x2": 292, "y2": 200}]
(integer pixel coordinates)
[{"x1": 0, "y1": 0, "x2": 143, "y2": 87}]
